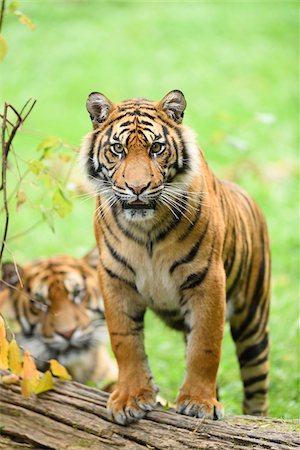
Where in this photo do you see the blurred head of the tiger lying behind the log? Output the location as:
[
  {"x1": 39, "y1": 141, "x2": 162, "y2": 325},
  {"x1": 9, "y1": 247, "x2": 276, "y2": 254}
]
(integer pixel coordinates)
[{"x1": 1, "y1": 251, "x2": 107, "y2": 368}]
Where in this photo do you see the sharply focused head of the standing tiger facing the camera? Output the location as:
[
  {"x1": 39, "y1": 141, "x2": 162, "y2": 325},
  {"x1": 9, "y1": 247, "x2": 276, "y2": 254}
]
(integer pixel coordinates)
[{"x1": 81, "y1": 90, "x2": 199, "y2": 220}]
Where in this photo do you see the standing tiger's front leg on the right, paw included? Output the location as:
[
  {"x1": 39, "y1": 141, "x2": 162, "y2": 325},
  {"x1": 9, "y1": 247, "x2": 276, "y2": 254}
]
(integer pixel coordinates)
[{"x1": 177, "y1": 264, "x2": 225, "y2": 419}]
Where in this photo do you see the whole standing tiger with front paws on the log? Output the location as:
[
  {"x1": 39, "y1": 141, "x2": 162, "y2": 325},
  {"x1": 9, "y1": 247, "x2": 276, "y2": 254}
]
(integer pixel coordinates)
[{"x1": 81, "y1": 90, "x2": 270, "y2": 425}]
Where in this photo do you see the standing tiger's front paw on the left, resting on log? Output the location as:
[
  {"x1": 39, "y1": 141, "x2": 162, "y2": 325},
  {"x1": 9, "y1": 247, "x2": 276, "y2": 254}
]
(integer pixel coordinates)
[{"x1": 107, "y1": 387, "x2": 157, "y2": 425}]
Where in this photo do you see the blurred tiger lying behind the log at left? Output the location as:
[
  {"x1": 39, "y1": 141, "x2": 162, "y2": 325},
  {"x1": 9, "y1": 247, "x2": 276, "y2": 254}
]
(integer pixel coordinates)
[{"x1": 0, "y1": 251, "x2": 117, "y2": 391}]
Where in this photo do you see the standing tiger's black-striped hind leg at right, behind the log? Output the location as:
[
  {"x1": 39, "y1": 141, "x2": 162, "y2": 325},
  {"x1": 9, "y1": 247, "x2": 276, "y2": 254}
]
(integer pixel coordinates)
[{"x1": 229, "y1": 263, "x2": 269, "y2": 416}]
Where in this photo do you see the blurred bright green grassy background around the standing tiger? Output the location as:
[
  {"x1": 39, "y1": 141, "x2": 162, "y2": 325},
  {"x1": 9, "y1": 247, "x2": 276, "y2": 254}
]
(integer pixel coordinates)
[{"x1": 0, "y1": 0, "x2": 299, "y2": 418}]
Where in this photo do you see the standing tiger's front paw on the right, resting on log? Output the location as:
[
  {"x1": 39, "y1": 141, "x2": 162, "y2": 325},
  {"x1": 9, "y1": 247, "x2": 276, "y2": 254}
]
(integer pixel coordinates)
[{"x1": 176, "y1": 394, "x2": 224, "y2": 420}]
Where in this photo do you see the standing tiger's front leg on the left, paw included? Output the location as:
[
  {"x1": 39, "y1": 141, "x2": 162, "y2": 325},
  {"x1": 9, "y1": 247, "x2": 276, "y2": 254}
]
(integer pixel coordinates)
[{"x1": 100, "y1": 269, "x2": 157, "y2": 425}]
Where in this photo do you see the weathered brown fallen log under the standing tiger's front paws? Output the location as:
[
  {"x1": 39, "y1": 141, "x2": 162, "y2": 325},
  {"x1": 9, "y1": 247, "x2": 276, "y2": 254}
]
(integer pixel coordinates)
[{"x1": 0, "y1": 382, "x2": 300, "y2": 450}]
